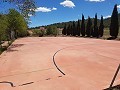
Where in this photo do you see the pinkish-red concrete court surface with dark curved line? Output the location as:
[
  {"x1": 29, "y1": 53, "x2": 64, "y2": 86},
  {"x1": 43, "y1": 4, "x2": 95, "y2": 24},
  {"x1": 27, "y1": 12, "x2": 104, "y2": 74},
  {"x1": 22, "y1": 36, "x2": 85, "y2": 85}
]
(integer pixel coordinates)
[{"x1": 0, "y1": 37, "x2": 120, "y2": 90}]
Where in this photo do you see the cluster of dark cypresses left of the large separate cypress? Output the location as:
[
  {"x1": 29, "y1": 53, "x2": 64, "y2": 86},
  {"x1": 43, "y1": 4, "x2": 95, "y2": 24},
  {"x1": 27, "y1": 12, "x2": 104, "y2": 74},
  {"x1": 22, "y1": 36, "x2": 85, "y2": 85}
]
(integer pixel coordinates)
[{"x1": 62, "y1": 14, "x2": 104, "y2": 37}]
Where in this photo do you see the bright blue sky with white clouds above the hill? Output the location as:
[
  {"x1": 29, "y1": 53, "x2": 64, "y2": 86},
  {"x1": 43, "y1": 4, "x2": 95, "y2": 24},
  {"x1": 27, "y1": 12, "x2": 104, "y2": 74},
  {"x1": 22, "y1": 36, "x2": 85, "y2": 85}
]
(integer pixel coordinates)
[{"x1": 0, "y1": 0, "x2": 120, "y2": 27}]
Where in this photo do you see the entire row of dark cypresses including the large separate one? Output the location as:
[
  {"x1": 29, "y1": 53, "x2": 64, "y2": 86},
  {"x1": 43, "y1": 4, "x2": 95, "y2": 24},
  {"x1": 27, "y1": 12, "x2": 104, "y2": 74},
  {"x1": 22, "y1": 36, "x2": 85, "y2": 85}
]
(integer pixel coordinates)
[{"x1": 62, "y1": 4, "x2": 119, "y2": 39}]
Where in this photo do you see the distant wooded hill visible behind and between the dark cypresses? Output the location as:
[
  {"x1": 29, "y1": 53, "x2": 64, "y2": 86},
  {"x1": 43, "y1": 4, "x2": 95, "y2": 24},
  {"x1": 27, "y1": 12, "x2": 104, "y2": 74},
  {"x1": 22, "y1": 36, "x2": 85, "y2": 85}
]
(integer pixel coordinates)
[{"x1": 29, "y1": 13, "x2": 120, "y2": 29}]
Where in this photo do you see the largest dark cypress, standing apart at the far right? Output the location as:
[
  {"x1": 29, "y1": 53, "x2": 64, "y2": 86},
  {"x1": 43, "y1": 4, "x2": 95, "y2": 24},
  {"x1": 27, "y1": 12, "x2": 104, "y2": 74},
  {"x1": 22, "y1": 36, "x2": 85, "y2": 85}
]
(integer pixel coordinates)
[{"x1": 110, "y1": 4, "x2": 119, "y2": 38}]
